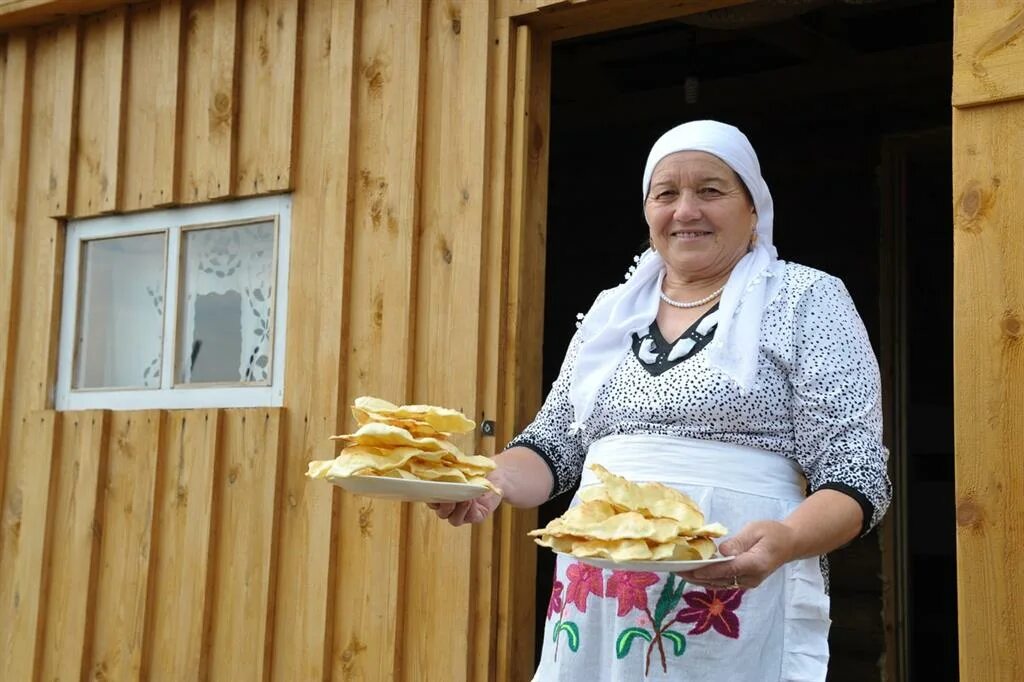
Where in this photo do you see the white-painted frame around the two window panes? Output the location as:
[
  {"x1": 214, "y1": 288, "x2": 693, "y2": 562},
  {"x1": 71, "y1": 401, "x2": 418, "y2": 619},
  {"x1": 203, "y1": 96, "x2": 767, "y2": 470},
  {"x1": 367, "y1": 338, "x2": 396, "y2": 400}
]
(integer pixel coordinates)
[{"x1": 54, "y1": 195, "x2": 292, "y2": 411}]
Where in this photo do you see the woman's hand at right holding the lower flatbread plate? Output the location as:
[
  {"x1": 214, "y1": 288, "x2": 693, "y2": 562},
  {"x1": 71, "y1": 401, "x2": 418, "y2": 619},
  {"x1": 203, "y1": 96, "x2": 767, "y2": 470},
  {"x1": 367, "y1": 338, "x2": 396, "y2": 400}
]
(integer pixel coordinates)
[{"x1": 679, "y1": 521, "x2": 797, "y2": 590}]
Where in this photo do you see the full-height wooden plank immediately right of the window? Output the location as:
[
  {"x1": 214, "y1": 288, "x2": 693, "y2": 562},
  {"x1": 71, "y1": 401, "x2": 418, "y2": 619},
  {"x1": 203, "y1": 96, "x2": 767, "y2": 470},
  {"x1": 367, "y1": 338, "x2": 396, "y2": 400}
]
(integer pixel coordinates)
[{"x1": 272, "y1": 0, "x2": 358, "y2": 682}]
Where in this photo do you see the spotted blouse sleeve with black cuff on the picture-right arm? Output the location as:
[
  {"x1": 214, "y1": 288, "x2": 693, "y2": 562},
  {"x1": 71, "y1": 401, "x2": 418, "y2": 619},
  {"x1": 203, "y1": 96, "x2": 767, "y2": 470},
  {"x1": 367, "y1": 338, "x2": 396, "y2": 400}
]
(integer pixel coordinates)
[{"x1": 792, "y1": 276, "x2": 892, "y2": 535}]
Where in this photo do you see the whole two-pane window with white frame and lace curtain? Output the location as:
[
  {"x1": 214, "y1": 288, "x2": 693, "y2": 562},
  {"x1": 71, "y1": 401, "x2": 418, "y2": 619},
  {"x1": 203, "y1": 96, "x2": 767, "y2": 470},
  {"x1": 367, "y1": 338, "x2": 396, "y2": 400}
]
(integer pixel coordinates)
[{"x1": 55, "y1": 197, "x2": 291, "y2": 410}]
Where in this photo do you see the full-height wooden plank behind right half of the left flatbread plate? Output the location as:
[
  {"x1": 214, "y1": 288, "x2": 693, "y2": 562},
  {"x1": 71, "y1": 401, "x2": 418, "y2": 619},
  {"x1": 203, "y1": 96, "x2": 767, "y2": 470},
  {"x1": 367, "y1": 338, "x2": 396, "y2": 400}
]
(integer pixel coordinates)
[{"x1": 401, "y1": 0, "x2": 490, "y2": 682}]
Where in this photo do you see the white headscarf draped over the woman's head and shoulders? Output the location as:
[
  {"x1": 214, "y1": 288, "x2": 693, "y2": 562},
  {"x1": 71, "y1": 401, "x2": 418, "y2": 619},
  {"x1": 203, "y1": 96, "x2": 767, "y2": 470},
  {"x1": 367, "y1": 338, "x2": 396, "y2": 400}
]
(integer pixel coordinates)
[{"x1": 569, "y1": 121, "x2": 783, "y2": 431}]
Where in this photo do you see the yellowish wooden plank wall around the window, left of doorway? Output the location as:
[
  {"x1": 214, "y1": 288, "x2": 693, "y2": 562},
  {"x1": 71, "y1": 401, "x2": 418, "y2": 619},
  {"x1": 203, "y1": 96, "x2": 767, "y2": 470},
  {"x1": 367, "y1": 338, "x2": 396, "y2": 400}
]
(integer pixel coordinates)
[{"x1": 0, "y1": 0, "x2": 546, "y2": 681}]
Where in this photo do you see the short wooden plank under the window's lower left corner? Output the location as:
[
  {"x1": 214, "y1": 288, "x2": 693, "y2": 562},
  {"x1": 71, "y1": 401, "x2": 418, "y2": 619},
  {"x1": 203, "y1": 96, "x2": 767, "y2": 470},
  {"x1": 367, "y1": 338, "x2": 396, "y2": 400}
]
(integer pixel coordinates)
[{"x1": 40, "y1": 411, "x2": 110, "y2": 680}]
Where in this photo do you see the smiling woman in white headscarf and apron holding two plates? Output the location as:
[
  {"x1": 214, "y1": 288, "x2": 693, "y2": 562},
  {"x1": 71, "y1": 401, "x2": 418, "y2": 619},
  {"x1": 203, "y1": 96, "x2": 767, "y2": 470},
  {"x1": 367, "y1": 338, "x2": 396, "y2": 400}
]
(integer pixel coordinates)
[{"x1": 434, "y1": 121, "x2": 890, "y2": 682}]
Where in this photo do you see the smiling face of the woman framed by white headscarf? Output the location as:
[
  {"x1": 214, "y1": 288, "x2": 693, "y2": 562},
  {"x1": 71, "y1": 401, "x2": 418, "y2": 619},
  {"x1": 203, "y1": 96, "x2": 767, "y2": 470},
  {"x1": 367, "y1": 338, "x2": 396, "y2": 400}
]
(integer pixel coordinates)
[{"x1": 644, "y1": 152, "x2": 757, "y2": 280}]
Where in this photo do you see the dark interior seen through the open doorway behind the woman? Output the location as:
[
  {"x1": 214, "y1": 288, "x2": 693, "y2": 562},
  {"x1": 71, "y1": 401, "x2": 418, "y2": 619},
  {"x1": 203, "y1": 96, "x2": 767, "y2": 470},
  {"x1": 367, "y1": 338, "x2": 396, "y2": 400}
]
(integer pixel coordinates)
[{"x1": 537, "y1": 0, "x2": 957, "y2": 682}]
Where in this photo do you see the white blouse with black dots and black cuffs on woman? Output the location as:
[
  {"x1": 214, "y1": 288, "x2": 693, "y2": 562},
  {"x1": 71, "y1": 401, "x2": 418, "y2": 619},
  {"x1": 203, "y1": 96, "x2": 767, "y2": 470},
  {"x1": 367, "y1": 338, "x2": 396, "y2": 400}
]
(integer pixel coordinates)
[{"x1": 509, "y1": 263, "x2": 891, "y2": 532}]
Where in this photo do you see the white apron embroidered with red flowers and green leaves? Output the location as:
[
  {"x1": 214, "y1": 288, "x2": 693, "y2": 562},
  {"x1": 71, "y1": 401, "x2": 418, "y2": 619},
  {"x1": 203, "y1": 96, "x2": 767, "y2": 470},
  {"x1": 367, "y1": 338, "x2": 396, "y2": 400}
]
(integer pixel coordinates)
[{"x1": 534, "y1": 435, "x2": 830, "y2": 682}]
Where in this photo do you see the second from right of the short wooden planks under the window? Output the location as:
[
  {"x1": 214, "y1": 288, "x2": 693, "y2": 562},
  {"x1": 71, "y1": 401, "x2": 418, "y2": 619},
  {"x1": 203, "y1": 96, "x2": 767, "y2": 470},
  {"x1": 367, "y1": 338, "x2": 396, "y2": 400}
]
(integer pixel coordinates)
[{"x1": 141, "y1": 410, "x2": 220, "y2": 680}]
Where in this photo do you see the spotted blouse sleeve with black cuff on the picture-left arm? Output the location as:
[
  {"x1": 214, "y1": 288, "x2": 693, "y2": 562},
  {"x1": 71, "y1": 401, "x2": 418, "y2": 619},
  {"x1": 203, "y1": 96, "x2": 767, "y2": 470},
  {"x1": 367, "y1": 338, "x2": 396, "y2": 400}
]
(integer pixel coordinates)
[{"x1": 508, "y1": 323, "x2": 587, "y2": 497}]
